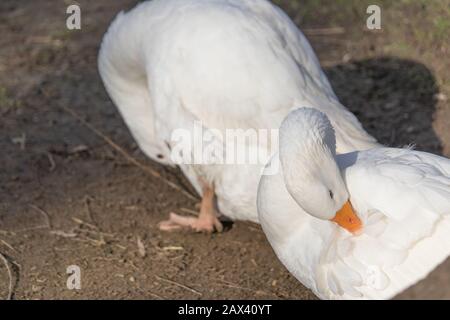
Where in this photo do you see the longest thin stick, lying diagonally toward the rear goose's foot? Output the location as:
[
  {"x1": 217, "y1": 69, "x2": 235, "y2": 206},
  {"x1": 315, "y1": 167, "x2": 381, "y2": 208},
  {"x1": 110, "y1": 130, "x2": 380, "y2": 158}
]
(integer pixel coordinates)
[{"x1": 42, "y1": 90, "x2": 198, "y2": 201}]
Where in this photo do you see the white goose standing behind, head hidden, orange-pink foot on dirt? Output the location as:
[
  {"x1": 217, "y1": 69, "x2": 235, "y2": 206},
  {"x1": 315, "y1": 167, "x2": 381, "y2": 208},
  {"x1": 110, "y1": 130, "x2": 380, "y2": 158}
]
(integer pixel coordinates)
[{"x1": 99, "y1": 0, "x2": 377, "y2": 231}]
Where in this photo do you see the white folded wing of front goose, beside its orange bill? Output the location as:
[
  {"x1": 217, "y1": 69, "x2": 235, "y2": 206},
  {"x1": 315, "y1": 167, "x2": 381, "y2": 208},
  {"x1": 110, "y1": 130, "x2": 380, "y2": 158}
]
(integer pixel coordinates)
[{"x1": 319, "y1": 148, "x2": 450, "y2": 299}]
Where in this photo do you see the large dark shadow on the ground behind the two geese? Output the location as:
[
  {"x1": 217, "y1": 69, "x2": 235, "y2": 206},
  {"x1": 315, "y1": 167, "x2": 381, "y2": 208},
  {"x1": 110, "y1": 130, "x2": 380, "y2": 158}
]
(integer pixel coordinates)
[{"x1": 325, "y1": 57, "x2": 442, "y2": 154}]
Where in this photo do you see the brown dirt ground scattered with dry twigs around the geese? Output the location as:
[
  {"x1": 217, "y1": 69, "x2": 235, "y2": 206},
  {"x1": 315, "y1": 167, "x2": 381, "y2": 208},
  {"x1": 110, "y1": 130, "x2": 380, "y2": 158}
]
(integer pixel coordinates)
[{"x1": 0, "y1": 0, "x2": 450, "y2": 299}]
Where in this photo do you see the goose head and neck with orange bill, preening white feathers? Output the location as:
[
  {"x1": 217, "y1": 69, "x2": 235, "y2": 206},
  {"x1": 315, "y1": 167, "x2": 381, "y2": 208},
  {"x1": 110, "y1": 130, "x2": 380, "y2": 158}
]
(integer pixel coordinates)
[{"x1": 279, "y1": 108, "x2": 362, "y2": 233}]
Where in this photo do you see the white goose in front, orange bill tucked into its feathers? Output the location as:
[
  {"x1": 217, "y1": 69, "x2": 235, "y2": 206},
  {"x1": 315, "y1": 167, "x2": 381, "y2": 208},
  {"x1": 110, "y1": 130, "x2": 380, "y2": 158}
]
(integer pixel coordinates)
[{"x1": 258, "y1": 108, "x2": 450, "y2": 299}]
